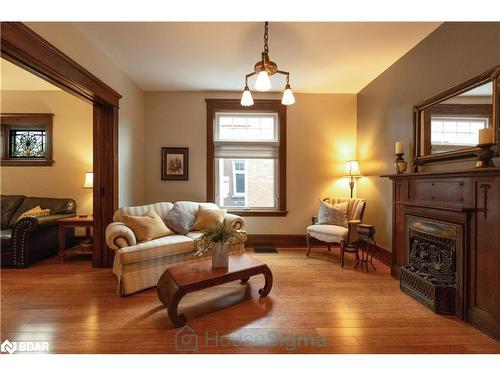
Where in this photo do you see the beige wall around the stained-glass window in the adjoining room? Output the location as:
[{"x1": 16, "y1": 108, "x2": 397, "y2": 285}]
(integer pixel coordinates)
[{"x1": 1, "y1": 90, "x2": 92, "y2": 214}]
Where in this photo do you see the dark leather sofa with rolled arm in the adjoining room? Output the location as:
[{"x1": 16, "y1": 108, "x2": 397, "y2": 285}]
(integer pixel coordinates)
[{"x1": 1, "y1": 195, "x2": 76, "y2": 268}]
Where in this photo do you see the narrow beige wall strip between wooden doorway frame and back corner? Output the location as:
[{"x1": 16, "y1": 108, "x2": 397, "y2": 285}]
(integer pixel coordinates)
[{"x1": 26, "y1": 22, "x2": 144, "y2": 206}]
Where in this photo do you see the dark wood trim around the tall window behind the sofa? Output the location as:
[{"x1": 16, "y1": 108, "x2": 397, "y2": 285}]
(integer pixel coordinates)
[{"x1": 205, "y1": 99, "x2": 287, "y2": 216}]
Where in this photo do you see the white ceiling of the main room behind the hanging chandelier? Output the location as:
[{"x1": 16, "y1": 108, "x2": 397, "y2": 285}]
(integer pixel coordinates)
[{"x1": 75, "y1": 22, "x2": 440, "y2": 93}]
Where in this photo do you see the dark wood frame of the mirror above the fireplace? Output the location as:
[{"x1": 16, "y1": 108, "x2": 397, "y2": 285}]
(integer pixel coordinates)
[{"x1": 413, "y1": 65, "x2": 500, "y2": 172}]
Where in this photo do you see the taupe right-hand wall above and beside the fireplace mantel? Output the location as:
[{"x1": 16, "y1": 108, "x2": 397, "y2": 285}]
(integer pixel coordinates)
[{"x1": 357, "y1": 23, "x2": 500, "y2": 253}]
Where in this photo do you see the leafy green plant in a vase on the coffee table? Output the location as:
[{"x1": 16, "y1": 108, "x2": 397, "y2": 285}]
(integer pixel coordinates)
[{"x1": 195, "y1": 223, "x2": 247, "y2": 268}]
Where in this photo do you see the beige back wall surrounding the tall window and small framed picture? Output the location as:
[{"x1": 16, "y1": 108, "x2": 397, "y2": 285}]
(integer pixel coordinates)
[{"x1": 144, "y1": 92, "x2": 356, "y2": 234}]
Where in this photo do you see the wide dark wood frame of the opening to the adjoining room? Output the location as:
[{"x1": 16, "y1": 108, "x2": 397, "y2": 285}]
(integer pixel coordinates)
[{"x1": 1, "y1": 22, "x2": 121, "y2": 267}]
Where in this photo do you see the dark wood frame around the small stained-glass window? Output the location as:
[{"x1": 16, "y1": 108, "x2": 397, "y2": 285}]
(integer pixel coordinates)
[{"x1": 0, "y1": 113, "x2": 54, "y2": 167}]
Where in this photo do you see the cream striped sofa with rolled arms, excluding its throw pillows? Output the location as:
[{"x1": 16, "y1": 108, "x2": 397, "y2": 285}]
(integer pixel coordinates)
[{"x1": 106, "y1": 201, "x2": 245, "y2": 296}]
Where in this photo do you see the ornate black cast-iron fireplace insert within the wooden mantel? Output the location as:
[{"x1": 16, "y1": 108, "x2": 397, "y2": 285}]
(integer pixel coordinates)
[{"x1": 400, "y1": 215, "x2": 463, "y2": 314}]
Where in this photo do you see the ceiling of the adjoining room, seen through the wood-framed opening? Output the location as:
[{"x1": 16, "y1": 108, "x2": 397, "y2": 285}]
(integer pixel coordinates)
[{"x1": 0, "y1": 59, "x2": 60, "y2": 91}]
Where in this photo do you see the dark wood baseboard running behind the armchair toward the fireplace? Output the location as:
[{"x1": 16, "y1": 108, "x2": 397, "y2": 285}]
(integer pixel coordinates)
[{"x1": 246, "y1": 234, "x2": 392, "y2": 267}]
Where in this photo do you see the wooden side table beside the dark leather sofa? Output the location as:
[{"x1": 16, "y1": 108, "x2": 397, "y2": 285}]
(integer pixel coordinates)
[{"x1": 57, "y1": 215, "x2": 94, "y2": 262}]
